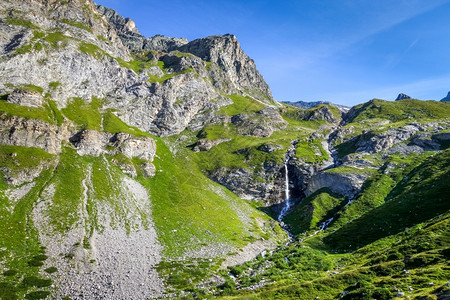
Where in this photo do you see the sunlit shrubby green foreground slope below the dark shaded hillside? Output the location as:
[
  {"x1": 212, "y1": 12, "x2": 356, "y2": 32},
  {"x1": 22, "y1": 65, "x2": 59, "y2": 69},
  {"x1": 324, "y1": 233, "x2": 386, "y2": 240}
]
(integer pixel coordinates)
[{"x1": 222, "y1": 213, "x2": 450, "y2": 299}]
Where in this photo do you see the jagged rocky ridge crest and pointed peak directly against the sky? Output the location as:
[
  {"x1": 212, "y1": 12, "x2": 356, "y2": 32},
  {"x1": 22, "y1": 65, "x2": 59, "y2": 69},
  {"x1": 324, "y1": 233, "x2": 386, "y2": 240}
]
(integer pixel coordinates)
[{"x1": 98, "y1": 5, "x2": 275, "y2": 105}]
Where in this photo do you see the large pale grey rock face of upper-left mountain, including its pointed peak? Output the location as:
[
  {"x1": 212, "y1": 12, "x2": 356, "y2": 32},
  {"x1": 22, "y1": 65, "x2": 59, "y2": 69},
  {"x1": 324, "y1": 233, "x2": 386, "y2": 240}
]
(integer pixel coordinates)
[{"x1": 0, "y1": 0, "x2": 276, "y2": 136}]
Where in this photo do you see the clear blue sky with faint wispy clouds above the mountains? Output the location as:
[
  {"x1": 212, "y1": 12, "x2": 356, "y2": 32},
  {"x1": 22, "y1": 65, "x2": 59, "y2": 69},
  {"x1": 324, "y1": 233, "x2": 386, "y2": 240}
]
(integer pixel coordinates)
[{"x1": 97, "y1": 0, "x2": 450, "y2": 105}]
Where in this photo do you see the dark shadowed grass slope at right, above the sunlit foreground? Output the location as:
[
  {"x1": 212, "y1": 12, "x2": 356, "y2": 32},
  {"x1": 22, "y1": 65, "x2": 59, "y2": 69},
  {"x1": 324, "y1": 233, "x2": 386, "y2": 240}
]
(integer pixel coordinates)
[{"x1": 324, "y1": 150, "x2": 450, "y2": 250}]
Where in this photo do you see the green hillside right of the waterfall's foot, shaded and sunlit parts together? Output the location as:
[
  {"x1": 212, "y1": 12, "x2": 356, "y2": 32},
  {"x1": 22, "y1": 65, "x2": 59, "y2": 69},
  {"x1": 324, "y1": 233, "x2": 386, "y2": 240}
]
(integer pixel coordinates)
[{"x1": 215, "y1": 140, "x2": 450, "y2": 299}]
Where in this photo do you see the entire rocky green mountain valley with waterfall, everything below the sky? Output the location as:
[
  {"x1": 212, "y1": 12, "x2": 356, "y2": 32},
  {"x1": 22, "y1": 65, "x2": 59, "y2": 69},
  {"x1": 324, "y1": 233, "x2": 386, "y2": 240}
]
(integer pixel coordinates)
[{"x1": 0, "y1": 0, "x2": 450, "y2": 299}]
